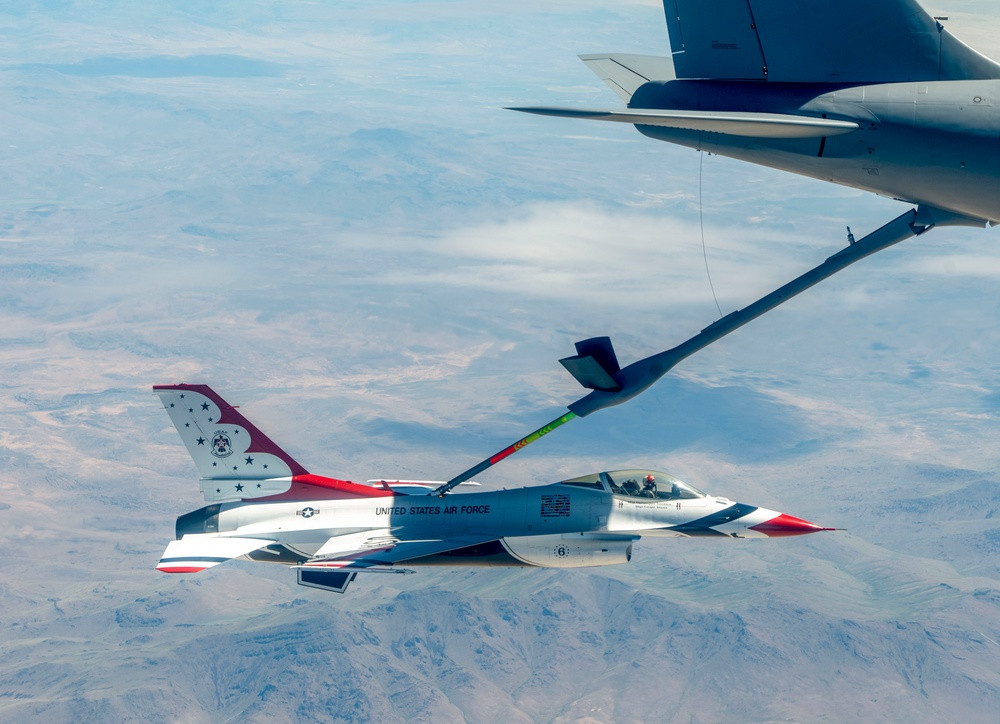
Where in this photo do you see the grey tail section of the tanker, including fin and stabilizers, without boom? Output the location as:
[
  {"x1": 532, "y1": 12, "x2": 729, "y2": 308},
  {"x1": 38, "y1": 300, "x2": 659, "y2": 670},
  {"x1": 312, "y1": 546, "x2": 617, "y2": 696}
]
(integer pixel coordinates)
[{"x1": 513, "y1": 0, "x2": 1000, "y2": 229}]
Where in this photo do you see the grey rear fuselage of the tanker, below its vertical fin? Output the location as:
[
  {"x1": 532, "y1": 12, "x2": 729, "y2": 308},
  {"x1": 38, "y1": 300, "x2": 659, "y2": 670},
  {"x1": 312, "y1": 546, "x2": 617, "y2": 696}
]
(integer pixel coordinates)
[{"x1": 629, "y1": 80, "x2": 1000, "y2": 221}]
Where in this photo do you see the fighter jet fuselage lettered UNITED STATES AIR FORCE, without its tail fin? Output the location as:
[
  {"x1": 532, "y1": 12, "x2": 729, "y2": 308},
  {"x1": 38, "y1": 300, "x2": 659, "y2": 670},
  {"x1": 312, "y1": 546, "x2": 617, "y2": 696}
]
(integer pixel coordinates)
[{"x1": 177, "y1": 473, "x2": 822, "y2": 567}]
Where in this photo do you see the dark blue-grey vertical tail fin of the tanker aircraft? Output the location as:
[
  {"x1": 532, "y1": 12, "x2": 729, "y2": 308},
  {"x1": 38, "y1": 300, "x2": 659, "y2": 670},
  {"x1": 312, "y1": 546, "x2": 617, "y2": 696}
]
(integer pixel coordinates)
[{"x1": 663, "y1": 0, "x2": 1000, "y2": 83}]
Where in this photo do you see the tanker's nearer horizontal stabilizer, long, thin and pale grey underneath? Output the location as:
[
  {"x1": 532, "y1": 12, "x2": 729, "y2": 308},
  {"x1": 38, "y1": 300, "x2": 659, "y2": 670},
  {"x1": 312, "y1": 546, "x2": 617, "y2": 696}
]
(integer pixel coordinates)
[{"x1": 507, "y1": 107, "x2": 858, "y2": 138}]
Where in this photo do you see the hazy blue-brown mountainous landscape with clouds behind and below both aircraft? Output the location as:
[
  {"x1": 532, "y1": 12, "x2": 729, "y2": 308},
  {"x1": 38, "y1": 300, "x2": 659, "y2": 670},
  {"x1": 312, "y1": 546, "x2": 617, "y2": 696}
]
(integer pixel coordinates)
[{"x1": 0, "y1": 0, "x2": 1000, "y2": 721}]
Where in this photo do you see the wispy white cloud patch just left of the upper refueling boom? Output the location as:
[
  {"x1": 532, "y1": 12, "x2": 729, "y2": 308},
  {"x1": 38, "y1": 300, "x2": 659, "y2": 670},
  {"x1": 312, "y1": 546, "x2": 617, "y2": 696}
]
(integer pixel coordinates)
[{"x1": 366, "y1": 203, "x2": 820, "y2": 311}]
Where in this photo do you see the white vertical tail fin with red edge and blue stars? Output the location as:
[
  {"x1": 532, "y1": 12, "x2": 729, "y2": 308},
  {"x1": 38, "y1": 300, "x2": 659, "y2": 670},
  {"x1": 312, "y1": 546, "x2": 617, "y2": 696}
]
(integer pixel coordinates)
[{"x1": 153, "y1": 385, "x2": 392, "y2": 502}]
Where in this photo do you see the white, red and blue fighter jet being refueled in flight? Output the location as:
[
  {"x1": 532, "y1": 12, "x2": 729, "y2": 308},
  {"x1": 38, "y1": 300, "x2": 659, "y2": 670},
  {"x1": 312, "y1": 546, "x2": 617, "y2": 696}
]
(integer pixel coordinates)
[{"x1": 153, "y1": 384, "x2": 833, "y2": 593}]
